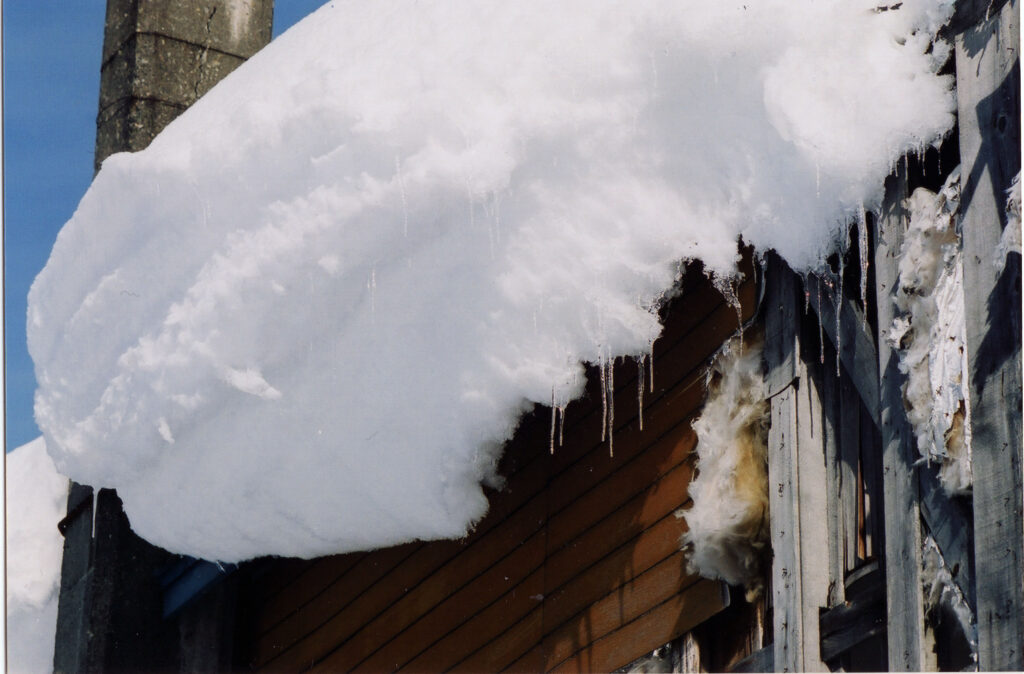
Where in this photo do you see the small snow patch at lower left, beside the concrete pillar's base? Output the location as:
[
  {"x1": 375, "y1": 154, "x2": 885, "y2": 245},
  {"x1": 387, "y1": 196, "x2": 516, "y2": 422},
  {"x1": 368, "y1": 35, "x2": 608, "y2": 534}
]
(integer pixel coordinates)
[{"x1": 7, "y1": 437, "x2": 69, "y2": 674}]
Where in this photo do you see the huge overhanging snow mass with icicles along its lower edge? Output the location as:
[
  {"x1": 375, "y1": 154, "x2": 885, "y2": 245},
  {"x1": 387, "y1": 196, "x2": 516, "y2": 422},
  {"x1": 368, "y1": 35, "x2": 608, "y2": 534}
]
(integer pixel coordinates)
[{"x1": 29, "y1": 0, "x2": 955, "y2": 560}]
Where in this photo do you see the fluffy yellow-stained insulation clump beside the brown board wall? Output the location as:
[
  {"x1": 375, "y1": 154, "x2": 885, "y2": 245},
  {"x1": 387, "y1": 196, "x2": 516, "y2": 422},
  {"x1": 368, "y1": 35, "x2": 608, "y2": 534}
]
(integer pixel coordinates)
[{"x1": 683, "y1": 337, "x2": 770, "y2": 599}]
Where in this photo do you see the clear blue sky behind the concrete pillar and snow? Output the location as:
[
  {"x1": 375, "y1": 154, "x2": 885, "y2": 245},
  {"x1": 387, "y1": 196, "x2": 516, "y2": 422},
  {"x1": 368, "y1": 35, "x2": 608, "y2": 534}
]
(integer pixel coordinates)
[{"x1": 3, "y1": 0, "x2": 324, "y2": 450}]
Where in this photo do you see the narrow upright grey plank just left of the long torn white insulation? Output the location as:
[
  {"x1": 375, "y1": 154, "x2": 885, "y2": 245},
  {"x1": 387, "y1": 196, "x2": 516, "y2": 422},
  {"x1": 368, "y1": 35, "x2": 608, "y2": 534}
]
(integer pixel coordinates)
[{"x1": 874, "y1": 164, "x2": 927, "y2": 671}]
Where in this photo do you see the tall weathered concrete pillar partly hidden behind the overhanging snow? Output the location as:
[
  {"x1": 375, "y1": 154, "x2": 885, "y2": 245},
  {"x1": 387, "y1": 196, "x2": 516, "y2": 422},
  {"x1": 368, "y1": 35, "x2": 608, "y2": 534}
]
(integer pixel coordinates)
[{"x1": 53, "y1": 0, "x2": 273, "y2": 672}]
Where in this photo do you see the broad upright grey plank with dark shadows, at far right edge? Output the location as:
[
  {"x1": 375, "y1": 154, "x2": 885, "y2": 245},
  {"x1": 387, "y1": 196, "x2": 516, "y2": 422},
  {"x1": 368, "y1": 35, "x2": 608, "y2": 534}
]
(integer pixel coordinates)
[{"x1": 955, "y1": 2, "x2": 1024, "y2": 670}]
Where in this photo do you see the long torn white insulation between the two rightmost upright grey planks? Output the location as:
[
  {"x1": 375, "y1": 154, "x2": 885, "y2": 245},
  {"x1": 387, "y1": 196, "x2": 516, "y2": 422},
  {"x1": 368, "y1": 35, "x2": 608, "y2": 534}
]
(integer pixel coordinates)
[{"x1": 889, "y1": 168, "x2": 972, "y2": 494}]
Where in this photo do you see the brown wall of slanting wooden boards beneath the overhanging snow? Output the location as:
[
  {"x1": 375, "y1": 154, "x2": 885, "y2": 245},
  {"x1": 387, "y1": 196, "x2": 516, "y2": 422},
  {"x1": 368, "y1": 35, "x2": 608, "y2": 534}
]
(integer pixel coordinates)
[{"x1": 235, "y1": 264, "x2": 755, "y2": 671}]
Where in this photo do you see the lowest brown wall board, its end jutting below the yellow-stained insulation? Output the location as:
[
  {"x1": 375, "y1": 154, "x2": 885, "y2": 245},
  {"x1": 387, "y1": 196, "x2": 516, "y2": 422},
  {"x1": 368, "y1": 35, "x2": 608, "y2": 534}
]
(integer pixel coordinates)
[{"x1": 549, "y1": 580, "x2": 729, "y2": 673}]
